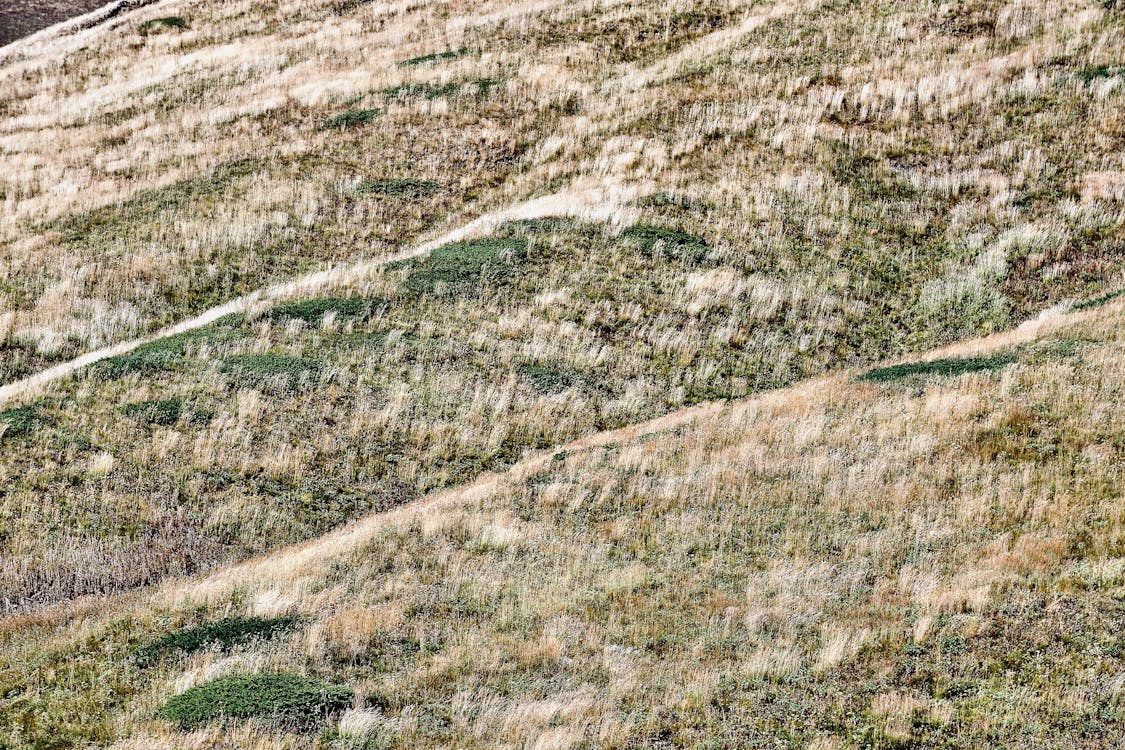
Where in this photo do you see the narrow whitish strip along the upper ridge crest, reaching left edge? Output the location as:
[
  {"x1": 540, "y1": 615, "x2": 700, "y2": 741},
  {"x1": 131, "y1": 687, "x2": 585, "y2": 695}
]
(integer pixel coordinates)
[{"x1": 0, "y1": 186, "x2": 641, "y2": 406}]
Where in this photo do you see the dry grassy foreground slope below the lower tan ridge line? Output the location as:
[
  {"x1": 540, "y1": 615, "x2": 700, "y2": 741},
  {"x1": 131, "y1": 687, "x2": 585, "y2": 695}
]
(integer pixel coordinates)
[{"x1": 0, "y1": 302, "x2": 1125, "y2": 748}]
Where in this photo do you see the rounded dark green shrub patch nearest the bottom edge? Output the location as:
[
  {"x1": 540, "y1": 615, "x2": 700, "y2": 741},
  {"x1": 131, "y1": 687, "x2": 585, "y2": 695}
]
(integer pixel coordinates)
[{"x1": 156, "y1": 674, "x2": 354, "y2": 731}]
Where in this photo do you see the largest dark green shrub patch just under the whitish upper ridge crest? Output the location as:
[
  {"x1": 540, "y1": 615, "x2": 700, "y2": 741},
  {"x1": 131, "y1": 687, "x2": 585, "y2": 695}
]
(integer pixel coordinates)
[{"x1": 403, "y1": 238, "x2": 528, "y2": 295}]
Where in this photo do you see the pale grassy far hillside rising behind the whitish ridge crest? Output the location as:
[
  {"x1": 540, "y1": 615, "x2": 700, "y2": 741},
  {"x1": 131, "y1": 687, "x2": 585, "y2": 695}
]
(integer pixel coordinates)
[{"x1": 0, "y1": 0, "x2": 1123, "y2": 380}]
